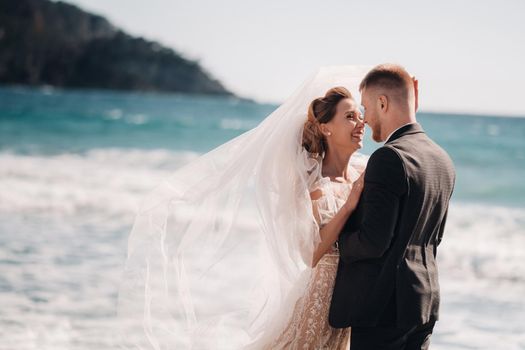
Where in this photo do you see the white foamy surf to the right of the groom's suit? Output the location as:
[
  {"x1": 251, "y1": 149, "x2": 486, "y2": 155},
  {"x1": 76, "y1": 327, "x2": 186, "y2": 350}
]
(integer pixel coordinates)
[{"x1": 433, "y1": 204, "x2": 525, "y2": 350}]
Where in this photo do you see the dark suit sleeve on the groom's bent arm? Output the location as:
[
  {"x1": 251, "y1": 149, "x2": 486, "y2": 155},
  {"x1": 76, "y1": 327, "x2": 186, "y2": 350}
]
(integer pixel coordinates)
[{"x1": 338, "y1": 146, "x2": 408, "y2": 263}]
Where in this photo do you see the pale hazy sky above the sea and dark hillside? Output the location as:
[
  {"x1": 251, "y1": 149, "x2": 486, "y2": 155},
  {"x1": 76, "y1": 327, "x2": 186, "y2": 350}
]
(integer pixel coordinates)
[{"x1": 62, "y1": 0, "x2": 525, "y2": 116}]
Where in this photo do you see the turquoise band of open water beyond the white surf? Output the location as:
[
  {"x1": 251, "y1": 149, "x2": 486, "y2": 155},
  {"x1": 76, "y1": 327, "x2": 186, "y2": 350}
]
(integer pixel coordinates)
[{"x1": 0, "y1": 88, "x2": 525, "y2": 207}]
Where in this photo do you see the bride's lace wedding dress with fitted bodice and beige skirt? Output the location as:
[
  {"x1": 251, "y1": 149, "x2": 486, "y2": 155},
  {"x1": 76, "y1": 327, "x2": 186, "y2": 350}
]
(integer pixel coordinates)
[{"x1": 266, "y1": 167, "x2": 359, "y2": 350}]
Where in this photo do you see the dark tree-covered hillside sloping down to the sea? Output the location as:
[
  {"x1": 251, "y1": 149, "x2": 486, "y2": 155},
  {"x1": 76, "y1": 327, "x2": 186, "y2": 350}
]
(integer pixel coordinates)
[{"x1": 0, "y1": 0, "x2": 232, "y2": 95}]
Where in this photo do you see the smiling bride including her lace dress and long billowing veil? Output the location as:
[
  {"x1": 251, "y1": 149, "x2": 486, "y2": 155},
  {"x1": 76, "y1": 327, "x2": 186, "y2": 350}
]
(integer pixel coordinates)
[{"x1": 118, "y1": 66, "x2": 366, "y2": 349}]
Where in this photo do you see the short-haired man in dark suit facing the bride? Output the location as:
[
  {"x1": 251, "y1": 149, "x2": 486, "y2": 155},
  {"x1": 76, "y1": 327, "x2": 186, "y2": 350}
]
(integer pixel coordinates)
[{"x1": 329, "y1": 64, "x2": 455, "y2": 350}]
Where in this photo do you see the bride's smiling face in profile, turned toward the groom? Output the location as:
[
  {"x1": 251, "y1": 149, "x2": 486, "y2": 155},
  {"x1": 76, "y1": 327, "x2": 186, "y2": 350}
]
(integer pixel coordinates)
[{"x1": 326, "y1": 98, "x2": 365, "y2": 151}]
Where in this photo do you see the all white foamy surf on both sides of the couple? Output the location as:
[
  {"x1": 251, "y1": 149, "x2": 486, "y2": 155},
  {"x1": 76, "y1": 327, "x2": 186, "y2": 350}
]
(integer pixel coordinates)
[{"x1": 0, "y1": 149, "x2": 525, "y2": 350}]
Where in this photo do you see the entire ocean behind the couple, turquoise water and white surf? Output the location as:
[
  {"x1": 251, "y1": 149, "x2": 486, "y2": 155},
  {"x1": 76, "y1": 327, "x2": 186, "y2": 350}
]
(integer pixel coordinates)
[{"x1": 0, "y1": 87, "x2": 525, "y2": 350}]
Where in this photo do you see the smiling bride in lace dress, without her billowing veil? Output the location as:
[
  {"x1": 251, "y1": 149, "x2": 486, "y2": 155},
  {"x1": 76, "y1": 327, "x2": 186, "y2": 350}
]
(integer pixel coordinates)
[{"x1": 267, "y1": 87, "x2": 364, "y2": 350}]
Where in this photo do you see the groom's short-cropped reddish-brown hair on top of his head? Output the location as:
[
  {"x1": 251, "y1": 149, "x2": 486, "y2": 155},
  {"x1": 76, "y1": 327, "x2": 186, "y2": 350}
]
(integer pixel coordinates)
[{"x1": 359, "y1": 63, "x2": 413, "y2": 98}]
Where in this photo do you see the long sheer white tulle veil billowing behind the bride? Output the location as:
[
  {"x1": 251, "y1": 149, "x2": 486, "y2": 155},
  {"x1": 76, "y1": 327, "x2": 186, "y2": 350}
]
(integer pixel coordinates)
[{"x1": 118, "y1": 66, "x2": 369, "y2": 349}]
